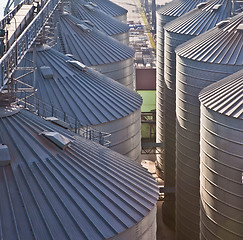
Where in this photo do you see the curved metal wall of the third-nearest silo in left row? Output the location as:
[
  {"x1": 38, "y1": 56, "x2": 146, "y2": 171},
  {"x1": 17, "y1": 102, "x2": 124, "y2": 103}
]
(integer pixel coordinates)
[{"x1": 91, "y1": 58, "x2": 135, "y2": 90}]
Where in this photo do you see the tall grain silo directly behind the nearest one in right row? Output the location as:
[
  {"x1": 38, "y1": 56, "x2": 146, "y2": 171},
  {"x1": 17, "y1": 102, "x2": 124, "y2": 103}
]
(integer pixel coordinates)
[{"x1": 176, "y1": 13, "x2": 243, "y2": 239}]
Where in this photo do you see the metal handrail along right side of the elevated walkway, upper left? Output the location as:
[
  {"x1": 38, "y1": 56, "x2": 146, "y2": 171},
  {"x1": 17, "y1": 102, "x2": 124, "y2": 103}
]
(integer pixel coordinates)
[{"x1": 0, "y1": 0, "x2": 61, "y2": 91}]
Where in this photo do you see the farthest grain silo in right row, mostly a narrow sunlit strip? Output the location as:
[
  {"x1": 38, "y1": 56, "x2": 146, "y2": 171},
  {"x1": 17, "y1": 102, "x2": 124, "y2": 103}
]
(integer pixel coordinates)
[{"x1": 156, "y1": 0, "x2": 204, "y2": 178}]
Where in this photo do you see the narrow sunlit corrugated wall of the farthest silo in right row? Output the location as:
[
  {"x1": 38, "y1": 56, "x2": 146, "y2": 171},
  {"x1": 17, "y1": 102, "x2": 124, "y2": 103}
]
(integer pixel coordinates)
[{"x1": 156, "y1": 12, "x2": 176, "y2": 178}]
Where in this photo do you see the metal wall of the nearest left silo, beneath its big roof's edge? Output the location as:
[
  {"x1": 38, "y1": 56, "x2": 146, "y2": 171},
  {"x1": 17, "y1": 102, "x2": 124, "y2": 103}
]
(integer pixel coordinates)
[{"x1": 110, "y1": 205, "x2": 157, "y2": 240}]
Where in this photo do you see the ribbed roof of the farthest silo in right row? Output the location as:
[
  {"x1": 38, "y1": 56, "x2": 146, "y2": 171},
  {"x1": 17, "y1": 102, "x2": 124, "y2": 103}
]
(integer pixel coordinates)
[{"x1": 157, "y1": 0, "x2": 204, "y2": 17}]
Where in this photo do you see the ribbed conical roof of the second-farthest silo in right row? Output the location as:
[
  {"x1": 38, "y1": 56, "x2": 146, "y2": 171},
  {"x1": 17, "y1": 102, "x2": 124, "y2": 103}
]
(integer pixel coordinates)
[{"x1": 164, "y1": 0, "x2": 232, "y2": 36}]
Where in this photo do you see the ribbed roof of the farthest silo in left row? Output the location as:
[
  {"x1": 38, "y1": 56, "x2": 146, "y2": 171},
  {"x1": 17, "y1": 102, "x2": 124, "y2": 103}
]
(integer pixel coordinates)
[{"x1": 82, "y1": 0, "x2": 128, "y2": 17}]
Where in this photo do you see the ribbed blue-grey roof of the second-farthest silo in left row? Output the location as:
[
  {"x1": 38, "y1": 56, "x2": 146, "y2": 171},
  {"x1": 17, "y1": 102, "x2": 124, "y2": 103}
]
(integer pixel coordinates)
[{"x1": 71, "y1": 0, "x2": 129, "y2": 36}]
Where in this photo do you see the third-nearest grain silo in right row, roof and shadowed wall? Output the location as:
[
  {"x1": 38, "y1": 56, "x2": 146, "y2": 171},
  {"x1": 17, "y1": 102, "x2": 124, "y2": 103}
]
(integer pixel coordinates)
[{"x1": 162, "y1": 0, "x2": 232, "y2": 229}]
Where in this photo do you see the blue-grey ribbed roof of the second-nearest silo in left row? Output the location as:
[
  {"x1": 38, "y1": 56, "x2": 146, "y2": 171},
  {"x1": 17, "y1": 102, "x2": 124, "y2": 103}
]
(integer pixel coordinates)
[{"x1": 18, "y1": 47, "x2": 142, "y2": 125}]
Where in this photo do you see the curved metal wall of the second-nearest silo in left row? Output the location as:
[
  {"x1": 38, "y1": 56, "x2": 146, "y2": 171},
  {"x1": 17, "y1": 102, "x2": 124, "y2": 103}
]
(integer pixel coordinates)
[{"x1": 93, "y1": 109, "x2": 141, "y2": 162}]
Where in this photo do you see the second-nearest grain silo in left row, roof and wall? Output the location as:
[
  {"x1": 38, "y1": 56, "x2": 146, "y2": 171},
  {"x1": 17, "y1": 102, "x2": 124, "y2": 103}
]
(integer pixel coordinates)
[{"x1": 16, "y1": 46, "x2": 142, "y2": 161}]
